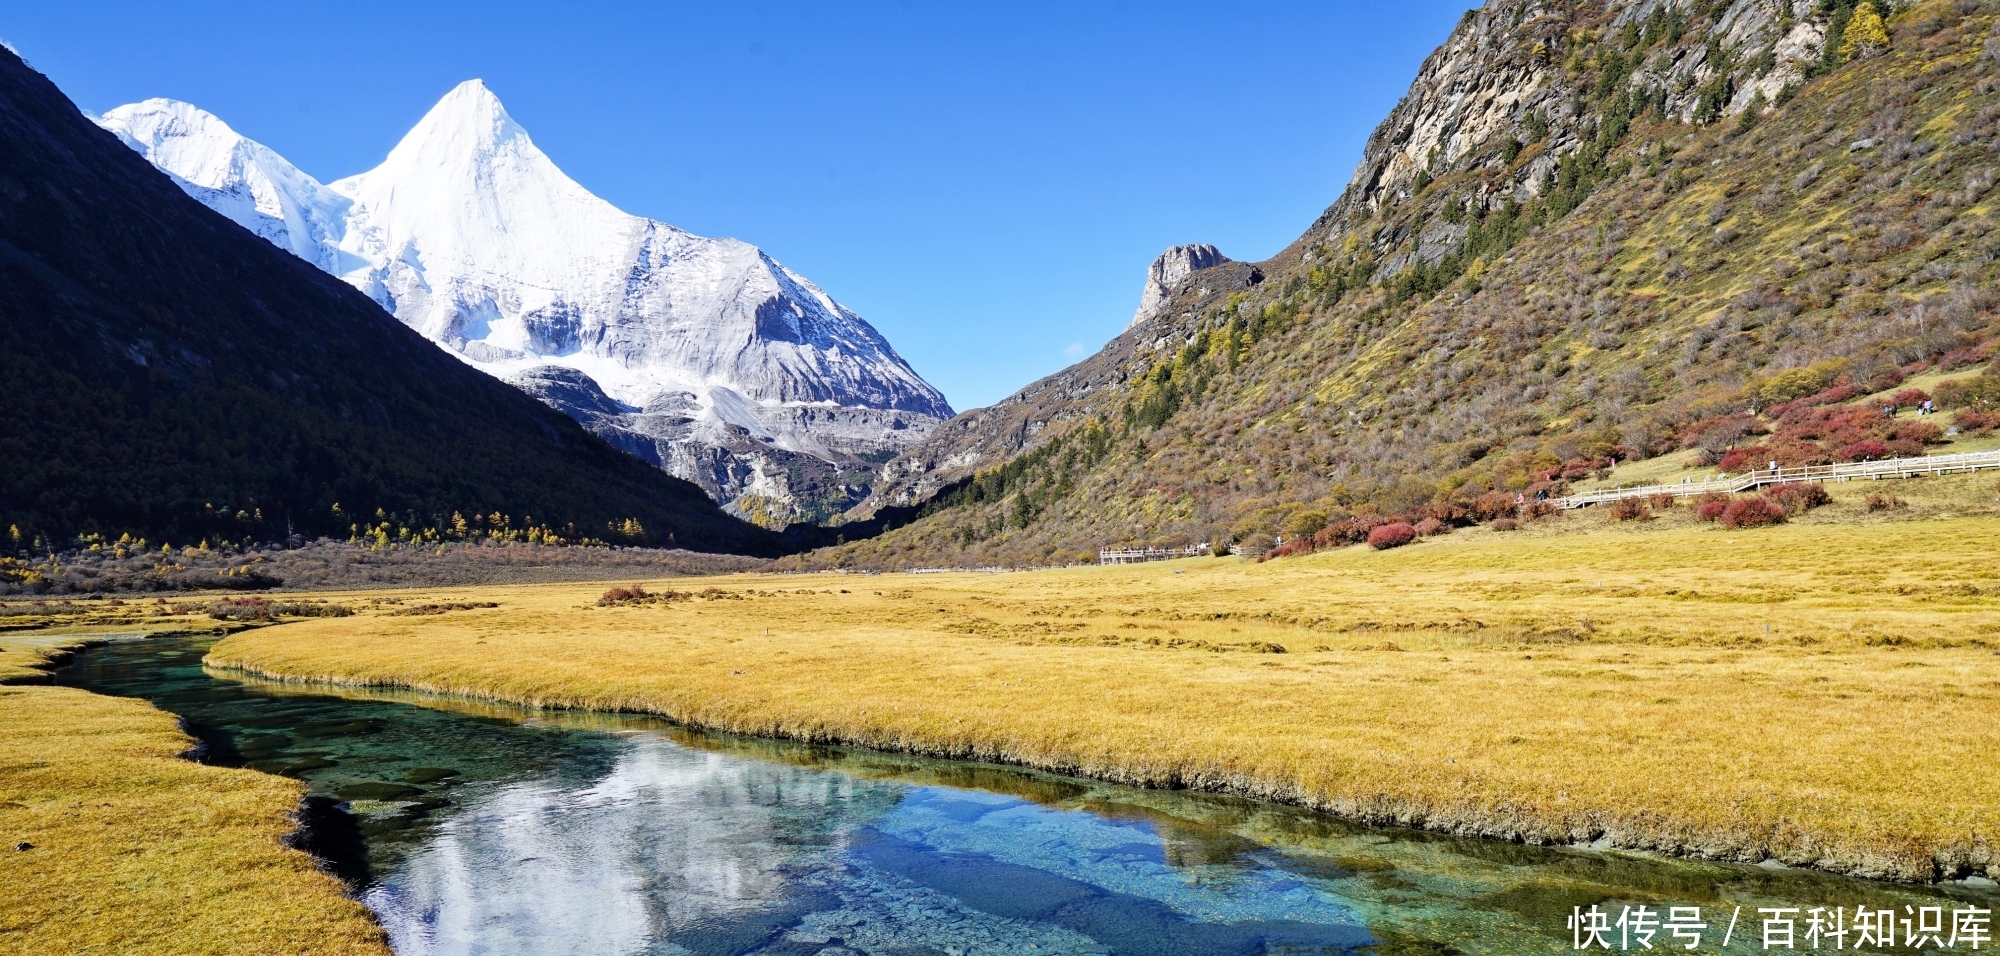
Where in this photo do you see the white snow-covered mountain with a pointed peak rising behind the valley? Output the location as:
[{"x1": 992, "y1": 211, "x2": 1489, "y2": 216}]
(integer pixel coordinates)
[{"x1": 98, "y1": 80, "x2": 952, "y2": 520}]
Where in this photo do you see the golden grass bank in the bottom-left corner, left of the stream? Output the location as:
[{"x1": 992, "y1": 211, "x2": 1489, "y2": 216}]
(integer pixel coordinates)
[{"x1": 0, "y1": 686, "x2": 388, "y2": 956}]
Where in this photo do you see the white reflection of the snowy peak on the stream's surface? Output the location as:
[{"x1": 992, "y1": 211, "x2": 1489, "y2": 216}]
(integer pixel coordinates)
[{"x1": 366, "y1": 736, "x2": 900, "y2": 956}]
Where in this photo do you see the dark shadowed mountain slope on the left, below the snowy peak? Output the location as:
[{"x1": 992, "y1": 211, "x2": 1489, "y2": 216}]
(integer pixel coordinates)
[{"x1": 0, "y1": 52, "x2": 780, "y2": 554}]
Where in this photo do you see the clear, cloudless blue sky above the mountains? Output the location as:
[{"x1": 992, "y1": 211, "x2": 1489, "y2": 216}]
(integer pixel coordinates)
[{"x1": 0, "y1": 0, "x2": 1468, "y2": 410}]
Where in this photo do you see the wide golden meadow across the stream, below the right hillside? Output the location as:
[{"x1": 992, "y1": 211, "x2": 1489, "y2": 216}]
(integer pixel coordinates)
[{"x1": 208, "y1": 490, "x2": 2000, "y2": 880}]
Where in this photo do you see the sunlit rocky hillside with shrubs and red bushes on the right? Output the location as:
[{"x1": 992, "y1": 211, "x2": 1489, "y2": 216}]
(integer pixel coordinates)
[{"x1": 800, "y1": 0, "x2": 2000, "y2": 568}]
